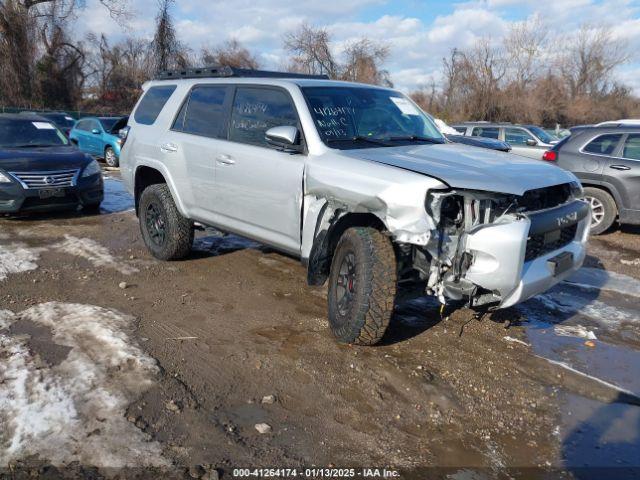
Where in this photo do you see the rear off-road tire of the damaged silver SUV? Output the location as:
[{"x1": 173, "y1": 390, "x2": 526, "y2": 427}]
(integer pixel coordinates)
[{"x1": 138, "y1": 183, "x2": 194, "y2": 260}]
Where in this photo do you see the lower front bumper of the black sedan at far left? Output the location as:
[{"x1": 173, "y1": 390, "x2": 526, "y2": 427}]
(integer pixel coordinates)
[{"x1": 0, "y1": 175, "x2": 104, "y2": 214}]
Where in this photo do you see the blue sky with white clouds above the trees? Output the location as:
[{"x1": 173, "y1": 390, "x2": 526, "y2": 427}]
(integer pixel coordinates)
[{"x1": 77, "y1": 0, "x2": 640, "y2": 94}]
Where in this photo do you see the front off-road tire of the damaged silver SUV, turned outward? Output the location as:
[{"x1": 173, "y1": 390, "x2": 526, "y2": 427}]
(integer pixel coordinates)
[{"x1": 328, "y1": 227, "x2": 397, "y2": 345}]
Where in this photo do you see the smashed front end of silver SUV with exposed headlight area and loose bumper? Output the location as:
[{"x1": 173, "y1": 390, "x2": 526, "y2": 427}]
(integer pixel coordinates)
[{"x1": 399, "y1": 183, "x2": 589, "y2": 308}]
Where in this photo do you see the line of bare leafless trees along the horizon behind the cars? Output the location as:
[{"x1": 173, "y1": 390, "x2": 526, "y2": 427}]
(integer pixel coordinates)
[{"x1": 0, "y1": 0, "x2": 640, "y2": 126}]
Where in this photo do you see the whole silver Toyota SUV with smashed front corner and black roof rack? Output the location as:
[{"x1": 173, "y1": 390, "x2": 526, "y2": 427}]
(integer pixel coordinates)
[{"x1": 121, "y1": 68, "x2": 589, "y2": 345}]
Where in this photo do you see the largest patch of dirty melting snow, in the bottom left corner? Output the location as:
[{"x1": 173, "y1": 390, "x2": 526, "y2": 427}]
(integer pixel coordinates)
[{"x1": 0, "y1": 303, "x2": 169, "y2": 468}]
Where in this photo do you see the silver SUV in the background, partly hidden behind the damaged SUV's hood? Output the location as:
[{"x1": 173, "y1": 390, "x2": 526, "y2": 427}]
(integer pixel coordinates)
[{"x1": 453, "y1": 122, "x2": 560, "y2": 160}]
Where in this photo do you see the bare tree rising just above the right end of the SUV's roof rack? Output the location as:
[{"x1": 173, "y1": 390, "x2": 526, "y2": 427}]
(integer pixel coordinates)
[{"x1": 284, "y1": 23, "x2": 340, "y2": 78}]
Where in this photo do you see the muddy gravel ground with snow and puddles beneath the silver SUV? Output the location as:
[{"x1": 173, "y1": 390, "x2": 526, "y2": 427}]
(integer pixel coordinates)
[{"x1": 0, "y1": 174, "x2": 640, "y2": 479}]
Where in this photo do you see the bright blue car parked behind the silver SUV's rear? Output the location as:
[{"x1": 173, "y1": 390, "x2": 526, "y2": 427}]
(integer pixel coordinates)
[{"x1": 69, "y1": 117, "x2": 128, "y2": 167}]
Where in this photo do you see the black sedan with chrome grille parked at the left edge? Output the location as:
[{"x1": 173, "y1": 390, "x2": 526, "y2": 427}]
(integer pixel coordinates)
[{"x1": 0, "y1": 115, "x2": 104, "y2": 214}]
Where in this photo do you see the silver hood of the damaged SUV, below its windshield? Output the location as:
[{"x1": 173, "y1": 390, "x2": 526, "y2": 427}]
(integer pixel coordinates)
[{"x1": 341, "y1": 144, "x2": 576, "y2": 195}]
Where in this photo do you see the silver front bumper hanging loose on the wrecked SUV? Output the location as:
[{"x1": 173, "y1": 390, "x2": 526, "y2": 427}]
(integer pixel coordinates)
[{"x1": 464, "y1": 200, "x2": 591, "y2": 308}]
